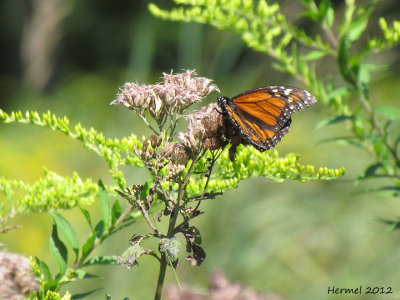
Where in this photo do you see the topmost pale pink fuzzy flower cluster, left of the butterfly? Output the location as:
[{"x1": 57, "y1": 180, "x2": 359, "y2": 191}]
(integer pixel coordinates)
[{"x1": 111, "y1": 70, "x2": 219, "y2": 122}]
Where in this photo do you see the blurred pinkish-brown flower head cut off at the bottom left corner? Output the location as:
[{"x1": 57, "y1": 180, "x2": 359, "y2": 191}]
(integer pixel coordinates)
[{"x1": 0, "y1": 252, "x2": 39, "y2": 300}]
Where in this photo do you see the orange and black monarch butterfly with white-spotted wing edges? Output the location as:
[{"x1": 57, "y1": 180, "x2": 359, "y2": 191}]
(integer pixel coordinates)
[{"x1": 218, "y1": 86, "x2": 317, "y2": 154}]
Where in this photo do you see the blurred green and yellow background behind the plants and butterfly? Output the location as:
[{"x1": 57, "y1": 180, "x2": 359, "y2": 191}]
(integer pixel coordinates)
[{"x1": 0, "y1": 0, "x2": 400, "y2": 299}]
